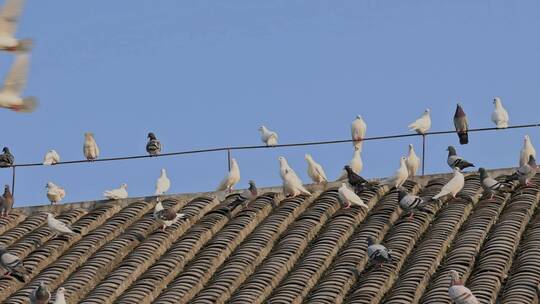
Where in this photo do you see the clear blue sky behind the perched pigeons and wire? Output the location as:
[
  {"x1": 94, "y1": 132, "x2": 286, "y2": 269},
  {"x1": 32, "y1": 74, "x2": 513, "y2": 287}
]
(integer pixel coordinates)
[{"x1": 0, "y1": 0, "x2": 540, "y2": 206}]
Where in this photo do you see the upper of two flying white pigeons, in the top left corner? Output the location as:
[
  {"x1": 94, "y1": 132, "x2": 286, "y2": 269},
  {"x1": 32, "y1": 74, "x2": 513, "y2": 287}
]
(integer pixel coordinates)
[{"x1": 0, "y1": 0, "x2": 32, "y2": 52}]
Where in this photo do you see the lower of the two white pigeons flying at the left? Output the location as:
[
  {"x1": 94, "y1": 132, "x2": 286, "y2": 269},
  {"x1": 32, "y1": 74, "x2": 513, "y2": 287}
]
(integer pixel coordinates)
[{"x1": 0, "y1": 54, "x2": 37, "y2": 113}]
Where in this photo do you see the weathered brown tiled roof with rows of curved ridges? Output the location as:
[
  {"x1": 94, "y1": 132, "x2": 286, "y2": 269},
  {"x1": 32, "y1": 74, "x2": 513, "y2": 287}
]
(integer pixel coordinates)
[{"x1": 0, "y1": 171, "x2": 540, "y2": 304}]
